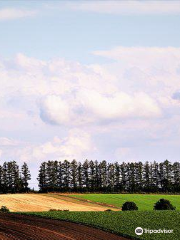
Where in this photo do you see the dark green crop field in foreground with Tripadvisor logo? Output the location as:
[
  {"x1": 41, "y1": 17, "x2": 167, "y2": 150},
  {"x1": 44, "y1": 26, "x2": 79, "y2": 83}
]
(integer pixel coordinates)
[{"x1": 21, "y1": 211, "x2": 180, "y2": 240}]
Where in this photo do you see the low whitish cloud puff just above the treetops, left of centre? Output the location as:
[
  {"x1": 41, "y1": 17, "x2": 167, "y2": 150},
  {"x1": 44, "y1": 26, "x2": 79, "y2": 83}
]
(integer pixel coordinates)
[{"x1": 16, "y1": 129, "x2": 96, "y2": 162}]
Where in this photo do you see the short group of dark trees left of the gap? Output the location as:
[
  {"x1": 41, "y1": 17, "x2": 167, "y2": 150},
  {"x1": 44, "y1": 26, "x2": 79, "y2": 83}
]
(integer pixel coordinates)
[{"x1": 0, "y1": 161, "x2": 31, "y2": 193}]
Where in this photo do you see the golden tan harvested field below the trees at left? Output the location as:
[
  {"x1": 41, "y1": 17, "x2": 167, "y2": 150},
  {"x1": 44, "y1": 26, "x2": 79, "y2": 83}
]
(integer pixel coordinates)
[{"x1": 0, "y1": 193, "x2": 116, "y2": 212}]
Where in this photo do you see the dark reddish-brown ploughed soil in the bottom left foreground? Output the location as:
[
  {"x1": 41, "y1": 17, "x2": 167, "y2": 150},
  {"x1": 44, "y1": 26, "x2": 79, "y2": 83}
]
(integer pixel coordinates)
[{"x1": 0, "y1": 213, "x2": 127, "y2": 240}]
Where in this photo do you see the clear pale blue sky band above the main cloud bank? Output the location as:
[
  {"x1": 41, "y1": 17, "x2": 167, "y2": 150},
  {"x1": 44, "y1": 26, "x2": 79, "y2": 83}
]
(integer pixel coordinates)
[{"x1": 0, "y1": 1, "x2": 180, "y2": 63}]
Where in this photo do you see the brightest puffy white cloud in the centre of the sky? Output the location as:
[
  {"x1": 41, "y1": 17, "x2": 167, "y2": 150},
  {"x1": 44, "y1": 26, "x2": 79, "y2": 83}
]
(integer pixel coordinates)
[{"x1": 40, "y1": 90, "x2": 161, "y2": 125}]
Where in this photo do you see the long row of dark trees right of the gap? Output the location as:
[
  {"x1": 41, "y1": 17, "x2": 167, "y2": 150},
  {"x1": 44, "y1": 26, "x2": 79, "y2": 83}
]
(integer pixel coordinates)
[{"x1": 38, "y1": 160, "x2": 180, "y2": 192}]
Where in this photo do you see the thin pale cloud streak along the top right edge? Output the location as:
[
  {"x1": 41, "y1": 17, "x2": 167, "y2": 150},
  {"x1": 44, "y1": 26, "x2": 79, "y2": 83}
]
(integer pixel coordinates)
[{"x1": 65, "y1": 1, "x2": 180, "y2": 15}]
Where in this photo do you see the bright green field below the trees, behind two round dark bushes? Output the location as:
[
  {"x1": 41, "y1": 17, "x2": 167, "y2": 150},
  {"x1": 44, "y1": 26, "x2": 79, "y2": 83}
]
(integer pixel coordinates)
[{"x1": 71, "y1": 194, "x2": 180, "y2": 211}]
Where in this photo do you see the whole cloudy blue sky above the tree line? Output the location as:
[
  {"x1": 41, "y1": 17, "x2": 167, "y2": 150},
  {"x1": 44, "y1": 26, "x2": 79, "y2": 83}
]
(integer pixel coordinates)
[{"x1": 0, "y1": 0, "x2": 180, "y2": 186}]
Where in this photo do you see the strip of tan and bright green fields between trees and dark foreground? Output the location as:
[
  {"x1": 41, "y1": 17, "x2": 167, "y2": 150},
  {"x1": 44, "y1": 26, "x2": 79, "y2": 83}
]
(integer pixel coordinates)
[{"x1": 0, "y1": 193, "x2": 180, "y2": 212}]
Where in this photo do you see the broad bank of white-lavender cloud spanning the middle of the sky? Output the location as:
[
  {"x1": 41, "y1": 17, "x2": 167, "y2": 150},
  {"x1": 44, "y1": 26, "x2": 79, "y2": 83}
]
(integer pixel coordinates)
[{"x1": 0, "y1": 51, "x2": 176, "y2": 127}]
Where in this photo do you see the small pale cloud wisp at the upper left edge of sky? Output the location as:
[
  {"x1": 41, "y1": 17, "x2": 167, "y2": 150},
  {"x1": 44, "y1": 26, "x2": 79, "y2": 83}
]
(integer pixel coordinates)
[{"x1": 0, "y1": 8, "x2": 37, "y2": 21}]
